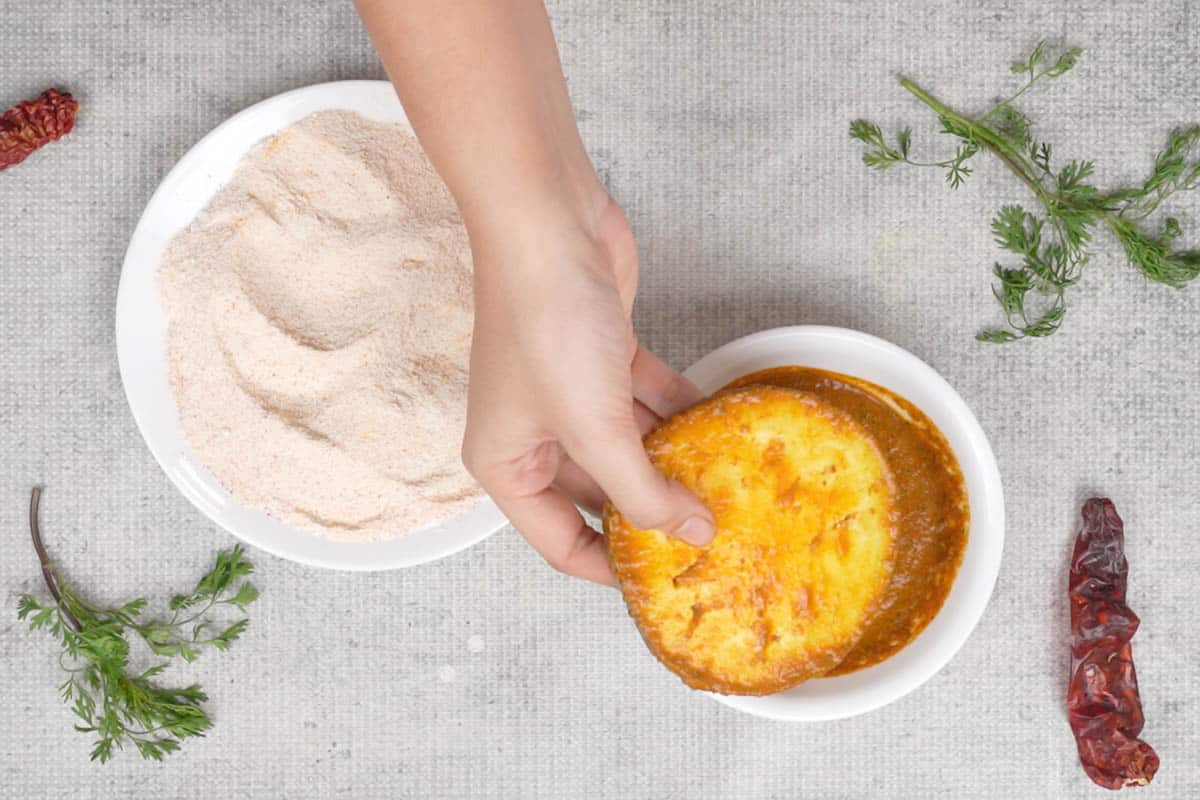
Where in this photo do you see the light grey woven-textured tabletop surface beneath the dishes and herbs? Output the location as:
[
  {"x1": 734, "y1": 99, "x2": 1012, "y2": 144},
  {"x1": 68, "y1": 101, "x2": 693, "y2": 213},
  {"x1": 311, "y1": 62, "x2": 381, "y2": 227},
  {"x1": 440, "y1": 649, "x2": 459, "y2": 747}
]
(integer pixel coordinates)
[{"x1": 0, "y1": 0, "x2": 1200, "y2": 800}]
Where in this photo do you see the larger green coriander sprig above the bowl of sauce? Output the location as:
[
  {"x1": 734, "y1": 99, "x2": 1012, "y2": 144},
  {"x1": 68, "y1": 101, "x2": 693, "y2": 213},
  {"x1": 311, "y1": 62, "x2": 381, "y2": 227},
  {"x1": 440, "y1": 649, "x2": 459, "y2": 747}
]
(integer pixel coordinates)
[{"x1": 850, "y1": 42, "x2": 1200, "y2": 343}]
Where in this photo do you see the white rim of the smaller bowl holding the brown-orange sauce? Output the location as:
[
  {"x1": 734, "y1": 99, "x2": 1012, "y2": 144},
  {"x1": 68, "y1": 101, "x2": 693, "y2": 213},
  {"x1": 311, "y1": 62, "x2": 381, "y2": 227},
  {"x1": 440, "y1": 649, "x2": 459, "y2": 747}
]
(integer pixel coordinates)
[{"x1": 684, "y1": 325, "x2": 1004, "y2": 722}]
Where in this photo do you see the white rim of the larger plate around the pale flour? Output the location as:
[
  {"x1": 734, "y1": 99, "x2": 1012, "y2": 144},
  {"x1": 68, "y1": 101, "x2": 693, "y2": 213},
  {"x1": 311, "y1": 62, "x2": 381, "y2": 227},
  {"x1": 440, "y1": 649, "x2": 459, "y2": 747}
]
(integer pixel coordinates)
[{"x1": 116, "y1": 80, "x2": 508, "y2": 570}]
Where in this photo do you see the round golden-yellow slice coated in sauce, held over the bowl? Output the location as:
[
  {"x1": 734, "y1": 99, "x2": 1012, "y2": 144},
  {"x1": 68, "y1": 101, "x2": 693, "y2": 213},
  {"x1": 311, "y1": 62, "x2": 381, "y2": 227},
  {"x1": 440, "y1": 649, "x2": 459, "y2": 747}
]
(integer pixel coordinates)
[{"x1": 604, "y1": 386, "x2": 895, "y2": 694}]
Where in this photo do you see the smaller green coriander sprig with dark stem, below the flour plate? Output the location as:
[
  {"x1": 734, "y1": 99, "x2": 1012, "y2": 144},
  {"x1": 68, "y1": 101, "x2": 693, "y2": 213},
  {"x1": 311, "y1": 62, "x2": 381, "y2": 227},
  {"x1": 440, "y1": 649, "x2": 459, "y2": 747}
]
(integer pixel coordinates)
[{"x1": 17, "y1": 488, "x2": 258, "y2": 763}]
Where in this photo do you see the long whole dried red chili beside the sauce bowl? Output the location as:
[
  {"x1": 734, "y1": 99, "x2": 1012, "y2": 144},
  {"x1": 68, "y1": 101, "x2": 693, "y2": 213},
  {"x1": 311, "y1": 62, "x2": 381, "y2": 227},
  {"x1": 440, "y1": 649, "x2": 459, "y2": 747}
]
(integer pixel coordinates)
[{"x1": 1067, "y1": 498, "x2": 1158, "y2": 789}]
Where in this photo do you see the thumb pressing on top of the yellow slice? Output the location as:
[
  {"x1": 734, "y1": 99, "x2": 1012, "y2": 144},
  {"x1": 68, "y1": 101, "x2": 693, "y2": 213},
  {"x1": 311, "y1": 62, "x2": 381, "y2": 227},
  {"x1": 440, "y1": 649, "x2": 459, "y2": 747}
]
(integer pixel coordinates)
[{"x1": 564, "y1": 413, "x2": 716, "y2": 546}]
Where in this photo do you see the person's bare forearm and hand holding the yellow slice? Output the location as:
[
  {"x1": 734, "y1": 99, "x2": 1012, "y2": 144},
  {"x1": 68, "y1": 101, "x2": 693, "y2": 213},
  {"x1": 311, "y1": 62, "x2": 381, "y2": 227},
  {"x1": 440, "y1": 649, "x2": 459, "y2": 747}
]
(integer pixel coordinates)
[{"x1": 355, "y1": 0, "x2": 713, "y2": 583}]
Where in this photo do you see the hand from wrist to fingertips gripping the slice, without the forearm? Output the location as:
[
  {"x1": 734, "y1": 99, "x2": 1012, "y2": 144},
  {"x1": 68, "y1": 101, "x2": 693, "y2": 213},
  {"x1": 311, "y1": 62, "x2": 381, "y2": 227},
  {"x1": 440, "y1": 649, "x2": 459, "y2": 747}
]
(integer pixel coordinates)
[{"x1": 463, "y1": 191, "x2": 714, "y2": 584}]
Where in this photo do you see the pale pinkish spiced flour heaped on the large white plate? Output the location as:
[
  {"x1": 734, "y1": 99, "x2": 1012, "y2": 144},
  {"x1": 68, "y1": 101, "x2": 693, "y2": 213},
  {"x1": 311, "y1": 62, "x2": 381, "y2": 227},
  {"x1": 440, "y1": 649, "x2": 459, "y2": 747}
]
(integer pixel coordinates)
[{"x1": 158, "y1": 112, "x2": 481, "y2": 539}]
